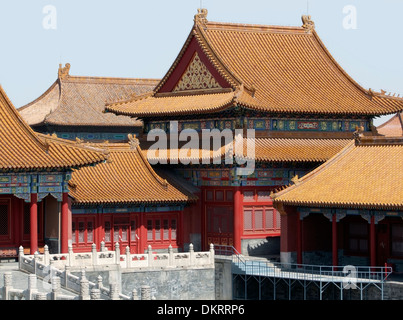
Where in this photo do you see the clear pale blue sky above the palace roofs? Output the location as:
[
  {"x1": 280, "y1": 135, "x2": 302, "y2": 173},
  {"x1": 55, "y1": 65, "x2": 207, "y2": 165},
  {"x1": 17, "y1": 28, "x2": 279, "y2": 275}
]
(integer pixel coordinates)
[{"x1": 0, "y1": 0, "x2": 403, "y2": 124}]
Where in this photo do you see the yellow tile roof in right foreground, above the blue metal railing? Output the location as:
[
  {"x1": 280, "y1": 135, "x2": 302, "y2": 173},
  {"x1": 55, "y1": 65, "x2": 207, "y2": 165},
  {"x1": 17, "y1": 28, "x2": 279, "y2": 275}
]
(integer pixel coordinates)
[{"x1": 274, "y1": 137, "x2": 403, "y2": 210}]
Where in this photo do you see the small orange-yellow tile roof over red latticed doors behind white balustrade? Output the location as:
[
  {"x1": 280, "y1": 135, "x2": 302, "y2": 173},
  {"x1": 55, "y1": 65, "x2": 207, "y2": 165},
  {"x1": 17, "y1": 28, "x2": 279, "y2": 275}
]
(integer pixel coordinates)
[{"x1": 69, "y1": 142, "x2": 192, "y2": 205}]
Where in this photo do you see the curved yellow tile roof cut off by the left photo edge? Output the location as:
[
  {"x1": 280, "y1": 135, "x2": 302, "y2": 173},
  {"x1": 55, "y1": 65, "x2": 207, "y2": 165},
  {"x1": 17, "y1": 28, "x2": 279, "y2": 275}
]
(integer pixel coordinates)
[{"x1": 0, "y1": 86, "x2": 108, "y2": 171}]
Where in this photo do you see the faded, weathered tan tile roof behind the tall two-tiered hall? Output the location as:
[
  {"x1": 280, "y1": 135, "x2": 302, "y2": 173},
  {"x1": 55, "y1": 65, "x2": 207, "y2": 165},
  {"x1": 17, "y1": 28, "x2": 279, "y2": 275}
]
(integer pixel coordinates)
[{"x1": 18, "y1": 63, "x2": 159, "y2": 126}]
